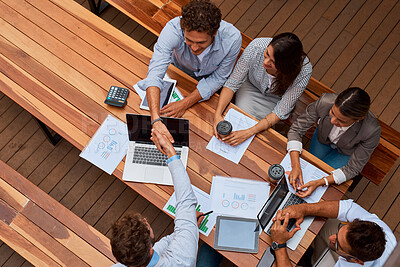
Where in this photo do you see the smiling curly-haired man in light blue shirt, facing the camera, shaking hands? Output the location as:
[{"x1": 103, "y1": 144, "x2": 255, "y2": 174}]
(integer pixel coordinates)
[{"x1": 138, "y1": 0, "x2": 242, "y2": 146}]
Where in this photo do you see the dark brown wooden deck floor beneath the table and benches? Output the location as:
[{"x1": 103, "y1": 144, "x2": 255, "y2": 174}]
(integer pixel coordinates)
[{"x1": 0, "y1": 0, "x2": 400, "y2": 266}]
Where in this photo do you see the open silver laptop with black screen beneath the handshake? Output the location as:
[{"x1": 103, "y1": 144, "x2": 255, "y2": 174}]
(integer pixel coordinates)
[{"x1": 122, "y1": 114, "x2": 189, "y2": 185}]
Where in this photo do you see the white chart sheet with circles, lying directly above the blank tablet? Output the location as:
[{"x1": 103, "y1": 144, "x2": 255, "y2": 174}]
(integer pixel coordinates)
[{"x1": 210, "y1": 176, "x2": 270, "y2": 219}]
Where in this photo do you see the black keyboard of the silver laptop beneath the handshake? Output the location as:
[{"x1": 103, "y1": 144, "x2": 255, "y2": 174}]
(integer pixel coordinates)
[{"x1": 132, "y1": 146, "x2": 181, "y2": 166}]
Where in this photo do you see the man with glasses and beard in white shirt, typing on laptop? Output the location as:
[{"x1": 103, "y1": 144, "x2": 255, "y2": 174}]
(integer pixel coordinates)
[{"x1": 271, "y1": 199, "x2": 397, "y2": 267}]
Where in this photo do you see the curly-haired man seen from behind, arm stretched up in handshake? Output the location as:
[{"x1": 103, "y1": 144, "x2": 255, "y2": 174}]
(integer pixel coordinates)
[{"x1": 111, "y1": 130, "x2": 199, "y2": 267}]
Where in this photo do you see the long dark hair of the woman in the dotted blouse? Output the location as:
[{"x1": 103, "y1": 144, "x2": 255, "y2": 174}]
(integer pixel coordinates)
[{"x1": 270, "y1": 32, "x2": 306, "y2": 96}]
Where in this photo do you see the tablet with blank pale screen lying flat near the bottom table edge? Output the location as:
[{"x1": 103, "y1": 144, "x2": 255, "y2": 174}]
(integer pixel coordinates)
[{"x1": 214, "y1": 216, "x2": 259, "y2": 253}]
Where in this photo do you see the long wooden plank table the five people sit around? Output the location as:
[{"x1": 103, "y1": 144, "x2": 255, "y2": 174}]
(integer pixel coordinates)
[{"x1": 0, "y1": 0, "x2": 349, "y2": 266}]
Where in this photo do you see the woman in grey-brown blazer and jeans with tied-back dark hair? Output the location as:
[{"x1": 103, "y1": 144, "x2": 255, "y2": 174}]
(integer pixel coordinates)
[{"x1": 287, "y1": 87, "x2": 381, "y2": 197}]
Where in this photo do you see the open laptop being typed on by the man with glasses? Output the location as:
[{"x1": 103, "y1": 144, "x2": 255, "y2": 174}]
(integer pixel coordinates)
[{"x1": 257, "y1": 177, "x2": 306, "y2": 235}]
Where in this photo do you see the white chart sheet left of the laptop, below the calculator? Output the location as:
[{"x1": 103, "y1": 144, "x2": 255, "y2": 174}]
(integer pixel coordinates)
[{"x1": 79, "y1": 115, "x2": 128, "y2": 174}]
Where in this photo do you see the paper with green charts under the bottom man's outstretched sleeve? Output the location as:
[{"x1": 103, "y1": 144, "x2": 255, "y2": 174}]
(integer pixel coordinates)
[{"x1": 163, "y1": 185, "x2": 217, "y2": 236}]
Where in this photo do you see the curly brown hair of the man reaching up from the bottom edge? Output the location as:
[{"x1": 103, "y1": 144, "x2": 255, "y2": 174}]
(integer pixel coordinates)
[{"x1": 110, "y1": 213, "x2": 152, "y2": 266}]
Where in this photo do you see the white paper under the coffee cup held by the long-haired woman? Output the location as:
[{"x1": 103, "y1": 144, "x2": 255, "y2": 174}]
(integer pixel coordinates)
[{"x1": 207, "y1": 108, "x2": 257, "y2": 164}]
